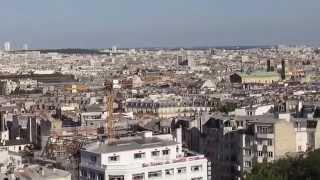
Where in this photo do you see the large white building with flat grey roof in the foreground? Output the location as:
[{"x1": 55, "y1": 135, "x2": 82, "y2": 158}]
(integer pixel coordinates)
[{"x1": 80, "y1": 129, "x2": 211, "y2": 180}]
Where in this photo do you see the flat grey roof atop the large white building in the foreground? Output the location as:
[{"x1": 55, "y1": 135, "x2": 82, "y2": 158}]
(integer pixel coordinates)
[{"x1": 84, "y1": 137, "x2": 177, "y2": 153}]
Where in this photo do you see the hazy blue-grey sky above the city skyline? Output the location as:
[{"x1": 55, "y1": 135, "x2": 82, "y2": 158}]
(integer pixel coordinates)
[{"x1": 0, "y1": 0, "x2": 320, "y2": 49}]
